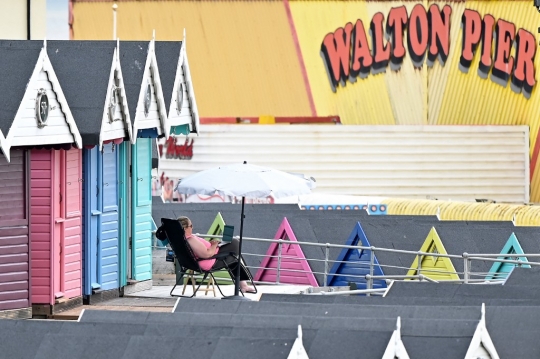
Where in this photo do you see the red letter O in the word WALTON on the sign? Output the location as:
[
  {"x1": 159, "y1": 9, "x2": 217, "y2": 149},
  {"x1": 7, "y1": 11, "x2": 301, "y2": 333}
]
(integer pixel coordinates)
[{"x1": 407, "y1": 4, "x2": 429, "y2": 67}]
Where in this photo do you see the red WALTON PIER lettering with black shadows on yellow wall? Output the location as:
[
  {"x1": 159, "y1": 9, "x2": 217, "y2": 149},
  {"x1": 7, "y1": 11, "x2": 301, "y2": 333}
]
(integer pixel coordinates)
[{"x1": 321, "y1": 4, "x2": 536, "y2": 99}]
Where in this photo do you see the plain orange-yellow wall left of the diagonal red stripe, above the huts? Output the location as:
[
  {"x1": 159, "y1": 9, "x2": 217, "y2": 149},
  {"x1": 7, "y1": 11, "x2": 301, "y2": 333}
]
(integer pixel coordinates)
[{"x1": 73, "y1": 1, "x2": 312, "y2": 117}]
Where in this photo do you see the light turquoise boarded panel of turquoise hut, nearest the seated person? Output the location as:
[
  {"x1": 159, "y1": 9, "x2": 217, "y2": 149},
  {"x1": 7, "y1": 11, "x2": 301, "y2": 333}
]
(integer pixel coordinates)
[{"x1": 131, "y1": 138, "x2": 152, "y2": 280}]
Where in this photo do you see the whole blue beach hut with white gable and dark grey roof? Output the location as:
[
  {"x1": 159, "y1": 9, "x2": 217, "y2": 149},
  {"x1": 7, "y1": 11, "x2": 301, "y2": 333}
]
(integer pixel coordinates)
[{"x1": 48, "y1": 41, "x2": 132, "y2": 301}]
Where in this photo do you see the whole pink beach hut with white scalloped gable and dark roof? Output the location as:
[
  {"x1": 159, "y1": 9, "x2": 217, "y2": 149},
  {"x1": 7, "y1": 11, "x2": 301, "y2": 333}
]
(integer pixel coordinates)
[{"x1": 0, "y1": 41, "x2": 82, "y2": 314}]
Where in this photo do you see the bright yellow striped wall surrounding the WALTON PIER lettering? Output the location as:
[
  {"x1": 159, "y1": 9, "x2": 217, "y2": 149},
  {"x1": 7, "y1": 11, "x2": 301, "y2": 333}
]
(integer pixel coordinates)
[{"x1": 290, "y1": 0, "x2": 540, "y2": 132}]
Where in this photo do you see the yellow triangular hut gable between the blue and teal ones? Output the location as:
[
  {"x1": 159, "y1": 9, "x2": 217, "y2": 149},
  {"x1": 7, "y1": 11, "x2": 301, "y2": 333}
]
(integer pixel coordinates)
[{"x1": 407, "y1": 227, "x2": 459, "y2": 280}]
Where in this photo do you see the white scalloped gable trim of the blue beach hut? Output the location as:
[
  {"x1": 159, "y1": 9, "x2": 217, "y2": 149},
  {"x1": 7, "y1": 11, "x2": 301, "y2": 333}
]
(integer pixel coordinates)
[{"x1": 99, "y1": 43, "x2": 133, "y2": 150}]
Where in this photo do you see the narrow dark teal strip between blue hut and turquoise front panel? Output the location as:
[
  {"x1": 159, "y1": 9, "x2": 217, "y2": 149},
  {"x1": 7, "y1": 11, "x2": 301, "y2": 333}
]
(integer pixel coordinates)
[{"x1": 118, "y1": 142, "x2": 131, "y2": 287}]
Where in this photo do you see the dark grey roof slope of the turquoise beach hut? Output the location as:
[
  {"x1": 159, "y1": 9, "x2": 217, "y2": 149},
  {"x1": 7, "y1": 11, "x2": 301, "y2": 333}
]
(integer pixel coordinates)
[{"x1": 120, "y1": 41, "x2": 150, "y2": 121}]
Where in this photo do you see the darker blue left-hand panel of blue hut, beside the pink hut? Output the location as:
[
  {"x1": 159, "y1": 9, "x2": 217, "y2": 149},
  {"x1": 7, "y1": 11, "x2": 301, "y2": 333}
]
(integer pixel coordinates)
[{"x1": 83, "y1": 148, "x2": 101, "y2": 295}]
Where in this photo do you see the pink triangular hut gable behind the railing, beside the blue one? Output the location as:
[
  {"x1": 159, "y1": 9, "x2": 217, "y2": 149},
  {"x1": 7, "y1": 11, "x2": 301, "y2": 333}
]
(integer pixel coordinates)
[{"x1": 254, "y1": 218, "x2": 319, "y2": 287}]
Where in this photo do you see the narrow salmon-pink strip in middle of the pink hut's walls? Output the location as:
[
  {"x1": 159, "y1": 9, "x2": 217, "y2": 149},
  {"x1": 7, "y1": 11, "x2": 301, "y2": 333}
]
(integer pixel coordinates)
[{"x1": 52, "y1": 150, "x2": 66, "y2": 302}]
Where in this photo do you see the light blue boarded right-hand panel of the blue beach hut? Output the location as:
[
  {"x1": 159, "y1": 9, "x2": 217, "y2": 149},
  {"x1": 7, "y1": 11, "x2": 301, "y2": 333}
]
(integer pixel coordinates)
[{"x1": 98, "y1": 144, "x2": 119, "y2": 290}]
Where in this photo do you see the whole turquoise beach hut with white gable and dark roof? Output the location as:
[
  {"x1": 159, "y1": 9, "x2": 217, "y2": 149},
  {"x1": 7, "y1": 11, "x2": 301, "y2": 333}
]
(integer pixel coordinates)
[{"x1": 119, "y1": 40, "x2": 168, "y2": 292}]
